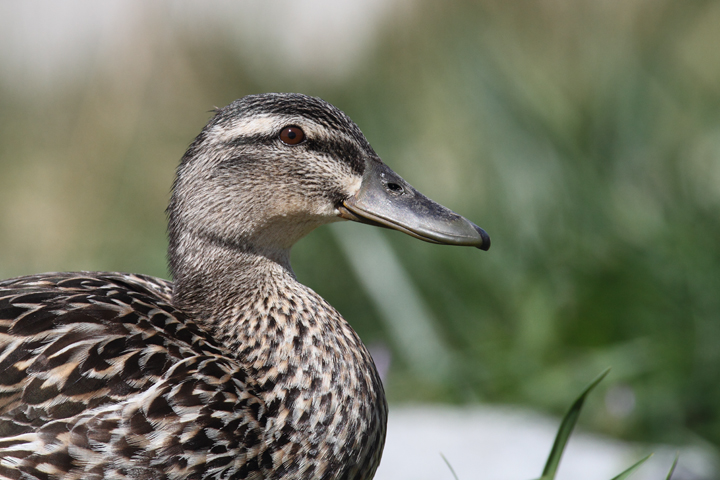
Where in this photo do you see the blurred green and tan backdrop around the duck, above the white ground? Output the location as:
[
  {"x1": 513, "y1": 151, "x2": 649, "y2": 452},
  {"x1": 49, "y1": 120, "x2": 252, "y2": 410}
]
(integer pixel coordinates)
[{"x1": 0, "y1": 0, "x2": 720, "y2": 458}]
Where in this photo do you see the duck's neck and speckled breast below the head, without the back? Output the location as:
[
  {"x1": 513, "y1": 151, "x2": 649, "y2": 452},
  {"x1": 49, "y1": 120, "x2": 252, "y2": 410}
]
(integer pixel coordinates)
[{"x1": 171, "y1": 231, "x2": 387, "y2": 479}]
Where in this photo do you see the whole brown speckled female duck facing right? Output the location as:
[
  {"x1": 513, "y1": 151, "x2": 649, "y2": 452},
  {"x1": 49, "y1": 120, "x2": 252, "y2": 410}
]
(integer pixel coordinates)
[{"x1": 0, "y1": 93, "x2": 490, "y2": 480}]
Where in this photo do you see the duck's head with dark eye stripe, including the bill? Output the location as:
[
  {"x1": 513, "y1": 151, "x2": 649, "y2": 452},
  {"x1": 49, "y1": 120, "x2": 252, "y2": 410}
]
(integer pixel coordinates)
[{"x1": 168, "y1": 94, "x2": 490, "y2": 270}]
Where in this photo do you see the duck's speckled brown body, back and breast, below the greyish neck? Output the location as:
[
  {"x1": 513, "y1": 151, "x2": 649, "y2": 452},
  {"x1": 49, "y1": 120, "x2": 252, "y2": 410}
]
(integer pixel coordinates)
[{"x1": 0, "y1": 274, "x2": 386, "y2": 480}]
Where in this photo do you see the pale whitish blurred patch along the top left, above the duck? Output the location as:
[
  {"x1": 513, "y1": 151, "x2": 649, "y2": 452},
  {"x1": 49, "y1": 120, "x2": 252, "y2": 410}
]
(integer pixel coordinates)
[{"x1": 0, "y1": 0, "x2": 412, "y2": 89}]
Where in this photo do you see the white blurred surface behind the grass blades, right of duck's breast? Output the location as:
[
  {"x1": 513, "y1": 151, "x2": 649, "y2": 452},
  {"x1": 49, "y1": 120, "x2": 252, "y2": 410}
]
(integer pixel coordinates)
[{"x1": 375, "y1": 405, "x2": 717, "y2": 480}]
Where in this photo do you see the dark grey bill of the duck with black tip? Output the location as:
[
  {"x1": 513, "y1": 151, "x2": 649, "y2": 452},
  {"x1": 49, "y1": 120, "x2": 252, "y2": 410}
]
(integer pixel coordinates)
[{"x1": 339, "y1": 161, "x2": 490, "y2": 250}]
